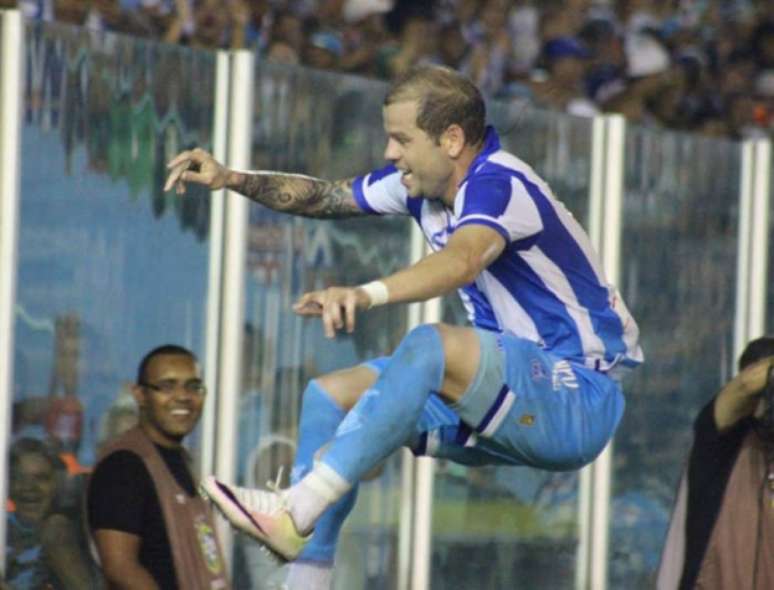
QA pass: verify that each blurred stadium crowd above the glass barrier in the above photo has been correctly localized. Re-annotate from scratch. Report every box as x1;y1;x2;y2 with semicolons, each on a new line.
0;0;774;139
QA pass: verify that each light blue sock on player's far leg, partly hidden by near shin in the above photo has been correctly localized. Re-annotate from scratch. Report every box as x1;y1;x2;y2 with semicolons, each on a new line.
291;380;357;564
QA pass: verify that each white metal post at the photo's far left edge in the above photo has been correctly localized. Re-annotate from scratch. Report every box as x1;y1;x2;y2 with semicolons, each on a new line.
0;10;24;575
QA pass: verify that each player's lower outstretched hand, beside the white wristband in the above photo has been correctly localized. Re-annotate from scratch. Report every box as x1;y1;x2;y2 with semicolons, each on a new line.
293;287;371;338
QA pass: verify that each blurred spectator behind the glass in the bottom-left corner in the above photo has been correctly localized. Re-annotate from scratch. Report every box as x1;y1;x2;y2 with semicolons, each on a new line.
5;438;98;590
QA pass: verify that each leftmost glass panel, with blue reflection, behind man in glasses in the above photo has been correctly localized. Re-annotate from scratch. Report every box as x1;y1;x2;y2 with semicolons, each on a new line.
6;24;215;588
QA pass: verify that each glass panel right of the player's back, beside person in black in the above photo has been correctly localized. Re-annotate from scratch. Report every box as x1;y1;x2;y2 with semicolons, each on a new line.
609;127;740;589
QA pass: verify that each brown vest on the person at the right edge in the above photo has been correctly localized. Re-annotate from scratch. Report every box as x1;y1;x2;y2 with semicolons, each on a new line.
695;432;774;590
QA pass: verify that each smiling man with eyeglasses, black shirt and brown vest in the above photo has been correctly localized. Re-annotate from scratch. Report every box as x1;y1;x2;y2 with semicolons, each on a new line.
87;345;230;590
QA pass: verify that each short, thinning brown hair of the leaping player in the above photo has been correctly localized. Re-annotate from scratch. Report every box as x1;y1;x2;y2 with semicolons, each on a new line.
384;65;486;145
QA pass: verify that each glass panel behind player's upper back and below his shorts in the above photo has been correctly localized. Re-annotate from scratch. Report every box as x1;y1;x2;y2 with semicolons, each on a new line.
431;104;591;590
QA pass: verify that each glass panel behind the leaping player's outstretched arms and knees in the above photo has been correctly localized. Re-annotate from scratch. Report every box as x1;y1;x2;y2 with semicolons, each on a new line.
234;64;410;590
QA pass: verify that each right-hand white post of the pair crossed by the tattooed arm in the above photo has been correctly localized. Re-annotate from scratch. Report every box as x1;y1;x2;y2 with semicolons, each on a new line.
214;51;255;559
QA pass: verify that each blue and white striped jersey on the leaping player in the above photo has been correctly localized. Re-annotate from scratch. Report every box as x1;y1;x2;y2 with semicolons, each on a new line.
353;127;643;371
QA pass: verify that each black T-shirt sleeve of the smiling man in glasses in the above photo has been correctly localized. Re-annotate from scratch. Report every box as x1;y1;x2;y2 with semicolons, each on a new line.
86;451;155;535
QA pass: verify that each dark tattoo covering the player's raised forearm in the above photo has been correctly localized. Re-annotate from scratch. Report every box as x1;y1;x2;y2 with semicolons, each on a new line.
235;173;365;219
